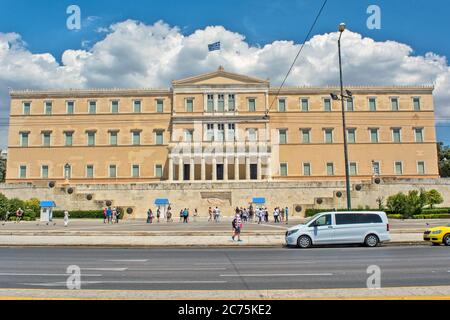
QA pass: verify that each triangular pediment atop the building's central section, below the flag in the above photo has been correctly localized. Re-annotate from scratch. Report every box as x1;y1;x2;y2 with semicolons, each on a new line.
172;67;269;87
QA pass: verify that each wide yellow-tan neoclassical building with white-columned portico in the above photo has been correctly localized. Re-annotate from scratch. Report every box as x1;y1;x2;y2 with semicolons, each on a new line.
6;68;439;185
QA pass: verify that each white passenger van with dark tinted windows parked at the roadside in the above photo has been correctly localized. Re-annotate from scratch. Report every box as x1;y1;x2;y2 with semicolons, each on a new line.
286;211;391;248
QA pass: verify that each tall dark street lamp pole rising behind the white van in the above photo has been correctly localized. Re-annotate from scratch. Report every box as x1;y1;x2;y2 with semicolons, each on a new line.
330;23;353;210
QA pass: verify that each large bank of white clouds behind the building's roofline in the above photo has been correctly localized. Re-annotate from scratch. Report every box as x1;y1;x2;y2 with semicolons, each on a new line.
0;20;450;146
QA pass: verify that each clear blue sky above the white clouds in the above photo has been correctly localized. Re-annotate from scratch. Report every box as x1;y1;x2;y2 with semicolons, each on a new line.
0;0;450;144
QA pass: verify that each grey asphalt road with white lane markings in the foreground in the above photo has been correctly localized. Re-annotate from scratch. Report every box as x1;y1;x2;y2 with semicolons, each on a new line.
0;246;450;292
